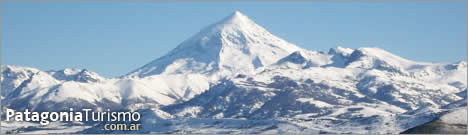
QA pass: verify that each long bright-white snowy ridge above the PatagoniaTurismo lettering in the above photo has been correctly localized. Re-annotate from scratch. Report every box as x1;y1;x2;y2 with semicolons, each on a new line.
2;66;214;111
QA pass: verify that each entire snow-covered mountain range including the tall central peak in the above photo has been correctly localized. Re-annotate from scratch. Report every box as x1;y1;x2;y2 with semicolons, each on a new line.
1;12;468;134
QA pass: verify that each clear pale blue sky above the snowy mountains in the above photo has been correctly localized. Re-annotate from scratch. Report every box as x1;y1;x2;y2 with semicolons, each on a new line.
1;1;467;77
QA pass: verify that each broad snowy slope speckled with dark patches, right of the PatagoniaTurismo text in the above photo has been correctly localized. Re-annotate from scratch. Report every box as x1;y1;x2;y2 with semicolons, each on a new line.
163;59;463;133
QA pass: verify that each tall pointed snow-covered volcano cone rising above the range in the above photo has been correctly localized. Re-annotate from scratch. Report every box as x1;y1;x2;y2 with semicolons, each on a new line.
129;11;300;77
